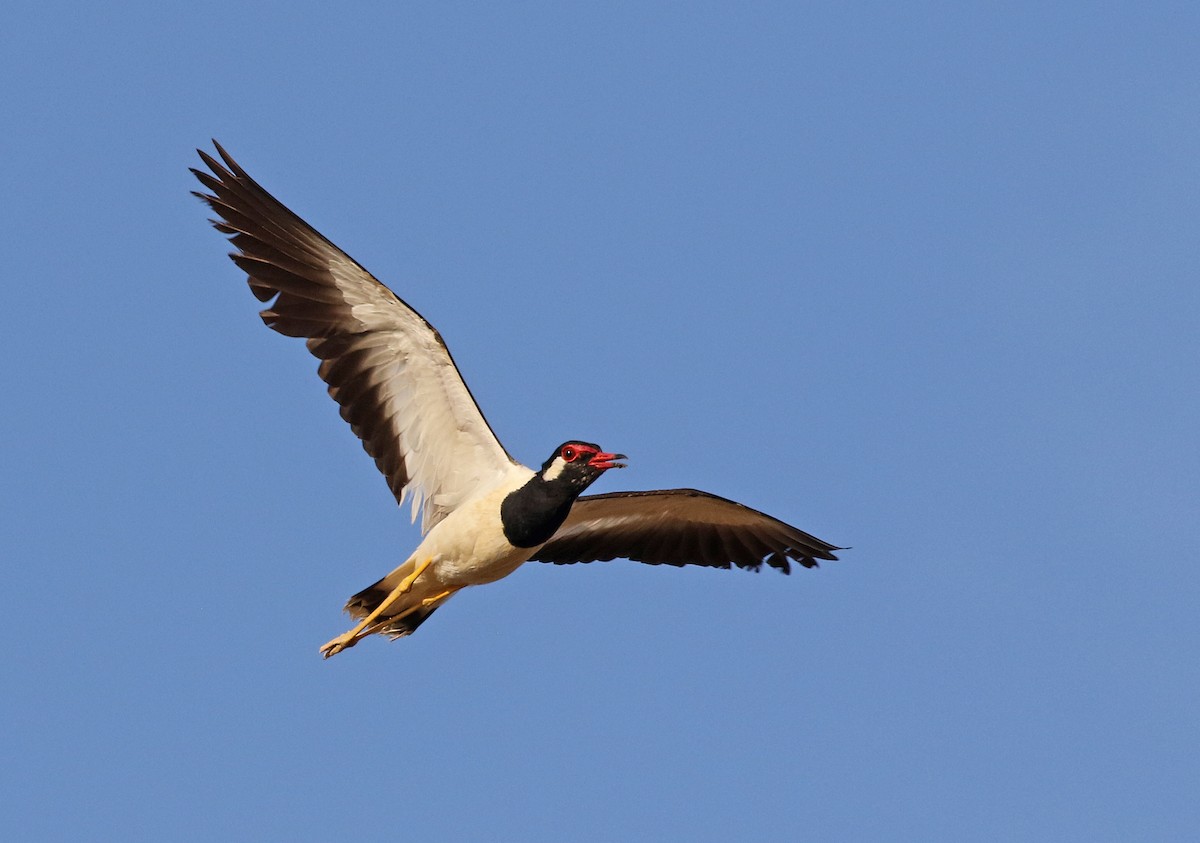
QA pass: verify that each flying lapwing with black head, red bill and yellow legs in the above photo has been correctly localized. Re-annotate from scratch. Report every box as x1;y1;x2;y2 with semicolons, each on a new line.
190;141;844;658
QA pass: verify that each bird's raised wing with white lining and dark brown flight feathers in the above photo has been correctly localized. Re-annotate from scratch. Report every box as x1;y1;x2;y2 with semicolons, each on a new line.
192;142;515;532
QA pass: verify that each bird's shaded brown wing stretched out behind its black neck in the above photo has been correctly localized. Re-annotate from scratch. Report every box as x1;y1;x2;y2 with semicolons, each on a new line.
533;489;842;574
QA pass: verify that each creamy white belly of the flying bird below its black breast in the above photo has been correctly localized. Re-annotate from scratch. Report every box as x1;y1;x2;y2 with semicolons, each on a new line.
413;467;538;586
